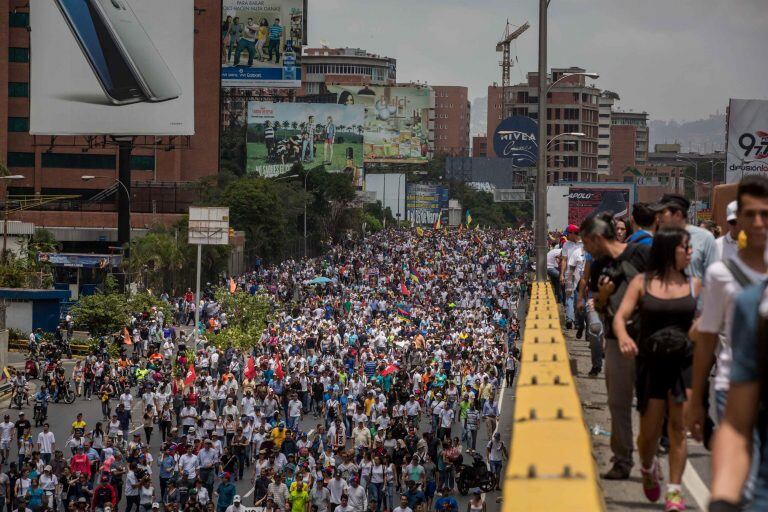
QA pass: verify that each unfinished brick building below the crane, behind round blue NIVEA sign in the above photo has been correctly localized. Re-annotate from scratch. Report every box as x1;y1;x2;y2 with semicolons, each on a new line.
487;67;602;183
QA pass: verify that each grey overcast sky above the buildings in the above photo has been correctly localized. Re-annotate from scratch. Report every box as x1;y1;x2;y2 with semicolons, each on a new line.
308;0;768;121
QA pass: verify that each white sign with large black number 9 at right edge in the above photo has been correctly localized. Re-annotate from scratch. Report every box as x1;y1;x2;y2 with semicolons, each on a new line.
725;99;768;183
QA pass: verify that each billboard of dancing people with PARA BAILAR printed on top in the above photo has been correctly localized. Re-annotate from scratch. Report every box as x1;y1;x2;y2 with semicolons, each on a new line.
221;0;306;88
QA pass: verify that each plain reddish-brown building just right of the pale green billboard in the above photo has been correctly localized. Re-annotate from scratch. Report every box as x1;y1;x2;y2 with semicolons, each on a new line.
432;85;471;156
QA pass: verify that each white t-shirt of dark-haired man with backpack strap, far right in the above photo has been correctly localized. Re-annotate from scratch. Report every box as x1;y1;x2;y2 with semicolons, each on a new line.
699;255;766;391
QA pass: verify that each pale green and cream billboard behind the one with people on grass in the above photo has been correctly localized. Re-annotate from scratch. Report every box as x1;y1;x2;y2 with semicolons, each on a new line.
328;85;432;164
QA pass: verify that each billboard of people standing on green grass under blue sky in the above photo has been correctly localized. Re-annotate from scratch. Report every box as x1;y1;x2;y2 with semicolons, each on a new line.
246;101;365;181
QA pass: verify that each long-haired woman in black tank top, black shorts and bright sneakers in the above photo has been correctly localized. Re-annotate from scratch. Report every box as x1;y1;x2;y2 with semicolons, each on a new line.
613;228;701;510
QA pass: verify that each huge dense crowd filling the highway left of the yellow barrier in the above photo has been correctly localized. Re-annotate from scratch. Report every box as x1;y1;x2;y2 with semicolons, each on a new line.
0;228;532;512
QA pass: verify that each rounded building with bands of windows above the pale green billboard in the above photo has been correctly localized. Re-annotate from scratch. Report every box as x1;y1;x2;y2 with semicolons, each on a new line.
299;48;397;96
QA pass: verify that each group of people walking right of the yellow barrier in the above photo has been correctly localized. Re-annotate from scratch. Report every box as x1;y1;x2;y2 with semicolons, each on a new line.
547;176;768;511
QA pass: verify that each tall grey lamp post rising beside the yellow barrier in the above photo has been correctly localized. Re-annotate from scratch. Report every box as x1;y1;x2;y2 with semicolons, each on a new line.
534;0;549;282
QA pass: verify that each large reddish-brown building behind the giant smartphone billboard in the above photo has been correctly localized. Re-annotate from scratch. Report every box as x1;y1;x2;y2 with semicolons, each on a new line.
0;0;221;250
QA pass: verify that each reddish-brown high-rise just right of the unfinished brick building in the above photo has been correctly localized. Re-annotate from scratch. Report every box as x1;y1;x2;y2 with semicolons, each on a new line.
610;110;648;181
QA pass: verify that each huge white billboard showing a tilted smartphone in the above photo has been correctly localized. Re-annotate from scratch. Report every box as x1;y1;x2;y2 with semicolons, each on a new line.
30;0;195;135
